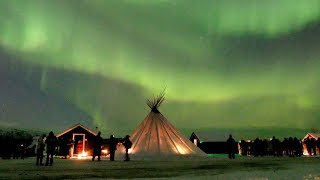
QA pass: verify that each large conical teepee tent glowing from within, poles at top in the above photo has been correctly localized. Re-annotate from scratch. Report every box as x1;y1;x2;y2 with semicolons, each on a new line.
118;91;206;158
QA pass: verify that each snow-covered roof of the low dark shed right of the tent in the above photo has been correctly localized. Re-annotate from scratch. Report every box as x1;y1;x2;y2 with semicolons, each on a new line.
193;131;229;142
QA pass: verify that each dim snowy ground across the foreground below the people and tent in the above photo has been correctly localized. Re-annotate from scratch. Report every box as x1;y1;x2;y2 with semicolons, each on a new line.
0;157;320;180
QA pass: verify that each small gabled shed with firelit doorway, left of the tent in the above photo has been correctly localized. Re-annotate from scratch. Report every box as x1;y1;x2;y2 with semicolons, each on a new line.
56;123;97;157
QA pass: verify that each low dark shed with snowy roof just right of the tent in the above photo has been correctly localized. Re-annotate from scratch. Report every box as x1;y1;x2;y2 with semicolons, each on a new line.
190;132;235;154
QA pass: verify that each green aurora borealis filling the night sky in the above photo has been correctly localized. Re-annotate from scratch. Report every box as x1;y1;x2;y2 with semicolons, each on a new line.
0;0;320;136
